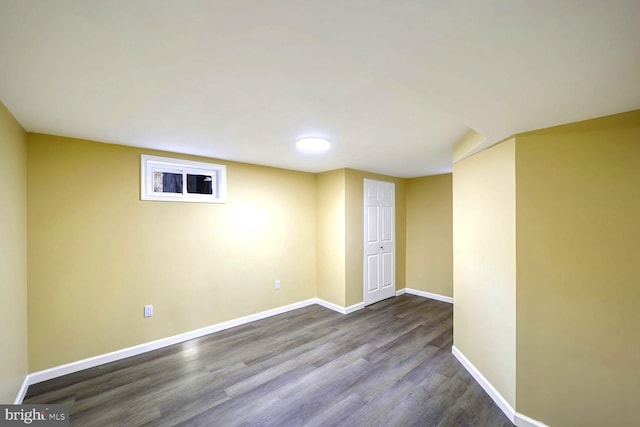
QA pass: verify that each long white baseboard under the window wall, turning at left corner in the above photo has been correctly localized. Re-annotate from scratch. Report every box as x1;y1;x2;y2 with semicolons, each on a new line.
16;298;317;404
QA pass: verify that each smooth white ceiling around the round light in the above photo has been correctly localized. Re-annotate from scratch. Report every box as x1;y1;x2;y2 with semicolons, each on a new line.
0;0;640;177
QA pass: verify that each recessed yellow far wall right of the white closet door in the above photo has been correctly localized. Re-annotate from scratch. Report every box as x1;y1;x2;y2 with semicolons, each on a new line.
406;173;453;297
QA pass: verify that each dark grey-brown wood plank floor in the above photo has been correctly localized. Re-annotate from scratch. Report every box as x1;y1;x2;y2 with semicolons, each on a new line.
25;295;512;427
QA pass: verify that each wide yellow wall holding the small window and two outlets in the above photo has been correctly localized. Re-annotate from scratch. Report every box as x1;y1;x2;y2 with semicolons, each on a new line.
27;134;316;371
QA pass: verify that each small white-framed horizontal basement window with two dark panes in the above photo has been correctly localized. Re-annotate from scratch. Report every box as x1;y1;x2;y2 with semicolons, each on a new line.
140;154;226;203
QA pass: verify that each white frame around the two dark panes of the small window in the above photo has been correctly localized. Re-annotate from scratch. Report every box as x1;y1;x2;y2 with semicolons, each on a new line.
140;154;227;203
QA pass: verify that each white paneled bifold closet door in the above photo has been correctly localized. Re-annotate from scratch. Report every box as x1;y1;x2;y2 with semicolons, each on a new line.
364;179;396;305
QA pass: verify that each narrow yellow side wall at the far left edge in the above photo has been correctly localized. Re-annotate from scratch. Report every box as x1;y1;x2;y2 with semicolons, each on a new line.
0;103;27;403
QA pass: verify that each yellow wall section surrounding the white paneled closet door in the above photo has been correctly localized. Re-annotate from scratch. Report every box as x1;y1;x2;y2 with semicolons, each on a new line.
345;169;406;306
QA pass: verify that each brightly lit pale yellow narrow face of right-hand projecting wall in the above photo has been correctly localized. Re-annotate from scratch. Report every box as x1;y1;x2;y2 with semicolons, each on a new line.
453;139;516;407
